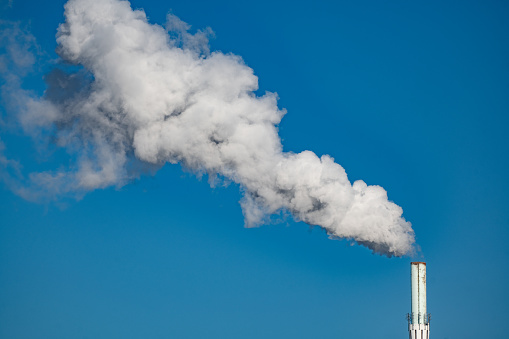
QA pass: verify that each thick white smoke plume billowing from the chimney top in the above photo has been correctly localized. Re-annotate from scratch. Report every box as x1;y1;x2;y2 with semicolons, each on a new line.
0;0;414;256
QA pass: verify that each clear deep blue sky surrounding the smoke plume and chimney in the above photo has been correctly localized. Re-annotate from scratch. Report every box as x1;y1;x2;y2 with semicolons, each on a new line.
0;0;509;339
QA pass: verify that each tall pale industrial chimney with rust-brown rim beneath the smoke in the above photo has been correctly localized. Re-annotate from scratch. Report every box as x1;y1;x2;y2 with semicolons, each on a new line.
407;262;430;339
